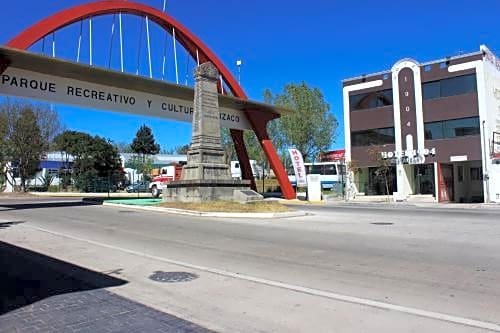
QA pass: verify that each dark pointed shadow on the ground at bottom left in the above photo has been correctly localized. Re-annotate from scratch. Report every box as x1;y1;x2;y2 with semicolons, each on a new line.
0;242;127;315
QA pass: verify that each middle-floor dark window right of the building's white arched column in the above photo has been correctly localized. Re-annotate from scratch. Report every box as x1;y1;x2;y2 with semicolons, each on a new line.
424;117;480;140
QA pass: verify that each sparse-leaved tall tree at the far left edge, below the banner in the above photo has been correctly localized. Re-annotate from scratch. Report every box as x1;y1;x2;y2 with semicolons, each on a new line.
0;99;62;191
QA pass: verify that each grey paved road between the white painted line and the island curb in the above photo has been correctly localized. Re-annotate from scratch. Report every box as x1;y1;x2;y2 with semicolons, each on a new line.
0;200;500;331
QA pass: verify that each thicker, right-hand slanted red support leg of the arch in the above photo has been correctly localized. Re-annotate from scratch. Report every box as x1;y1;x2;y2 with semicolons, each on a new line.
246;111;296;200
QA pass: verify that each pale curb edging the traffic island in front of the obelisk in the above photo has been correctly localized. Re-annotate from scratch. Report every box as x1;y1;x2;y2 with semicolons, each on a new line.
102;202;310;218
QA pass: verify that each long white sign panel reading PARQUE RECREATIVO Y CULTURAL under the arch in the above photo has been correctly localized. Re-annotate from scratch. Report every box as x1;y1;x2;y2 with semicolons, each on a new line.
0;67;251;130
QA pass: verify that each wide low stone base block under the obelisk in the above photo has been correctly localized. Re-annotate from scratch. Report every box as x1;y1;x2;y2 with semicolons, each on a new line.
162;179;250;202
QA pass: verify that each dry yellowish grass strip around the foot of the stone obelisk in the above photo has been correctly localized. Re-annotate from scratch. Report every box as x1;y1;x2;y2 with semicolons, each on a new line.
159;201;291;213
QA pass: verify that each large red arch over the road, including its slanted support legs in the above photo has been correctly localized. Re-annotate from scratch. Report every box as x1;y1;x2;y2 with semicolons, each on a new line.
7;0;295;199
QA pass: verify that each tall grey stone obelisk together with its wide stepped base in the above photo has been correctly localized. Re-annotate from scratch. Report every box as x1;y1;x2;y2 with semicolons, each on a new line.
163;62;250;202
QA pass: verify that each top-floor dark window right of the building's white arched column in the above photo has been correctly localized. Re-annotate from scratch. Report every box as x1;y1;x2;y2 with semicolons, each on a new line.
422;74;477;100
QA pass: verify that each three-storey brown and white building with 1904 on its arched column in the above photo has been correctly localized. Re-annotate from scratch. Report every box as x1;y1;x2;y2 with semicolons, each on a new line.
343;46;500;202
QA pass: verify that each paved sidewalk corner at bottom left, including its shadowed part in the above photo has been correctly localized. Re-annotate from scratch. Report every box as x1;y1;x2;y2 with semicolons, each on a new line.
0;242;210;333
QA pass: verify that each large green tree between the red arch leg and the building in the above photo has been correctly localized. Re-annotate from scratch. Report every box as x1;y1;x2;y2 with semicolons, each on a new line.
264;82;338;161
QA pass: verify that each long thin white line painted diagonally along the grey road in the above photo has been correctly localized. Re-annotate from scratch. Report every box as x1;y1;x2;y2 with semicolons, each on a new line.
20;225;500;332
